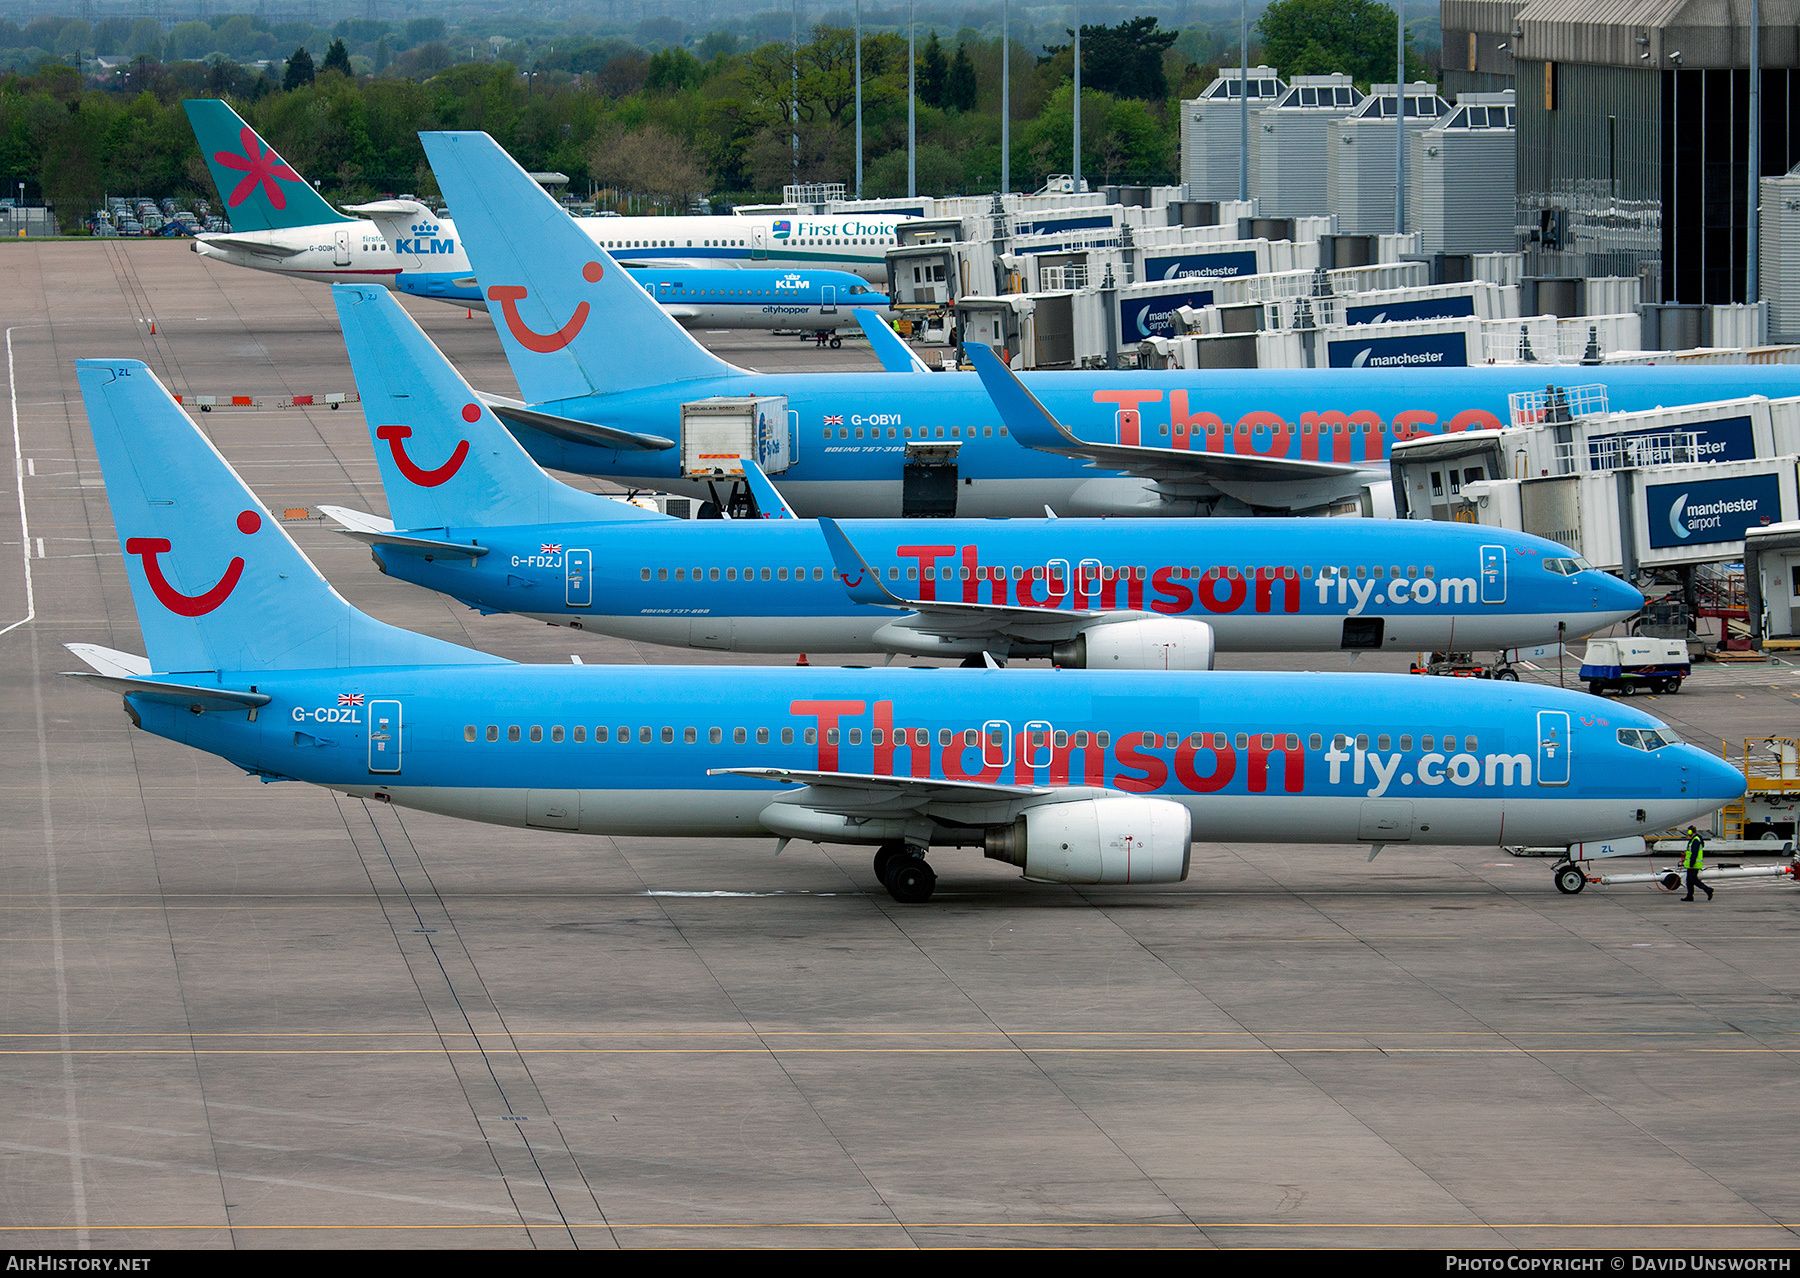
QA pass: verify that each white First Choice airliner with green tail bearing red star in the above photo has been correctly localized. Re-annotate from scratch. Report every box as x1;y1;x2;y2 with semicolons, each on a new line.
182;97;905;302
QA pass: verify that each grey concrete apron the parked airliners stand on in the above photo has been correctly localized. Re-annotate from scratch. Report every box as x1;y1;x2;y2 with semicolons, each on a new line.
0;241;1800;1247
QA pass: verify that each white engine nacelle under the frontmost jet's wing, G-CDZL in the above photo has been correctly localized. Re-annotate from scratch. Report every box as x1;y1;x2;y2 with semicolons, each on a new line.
985;797;1193;884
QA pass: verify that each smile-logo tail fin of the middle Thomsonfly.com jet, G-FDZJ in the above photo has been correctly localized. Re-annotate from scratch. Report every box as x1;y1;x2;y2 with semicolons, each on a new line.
331;284;668;529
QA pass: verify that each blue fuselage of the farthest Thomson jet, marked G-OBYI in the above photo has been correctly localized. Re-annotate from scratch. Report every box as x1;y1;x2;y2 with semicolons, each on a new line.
511;365;1800;518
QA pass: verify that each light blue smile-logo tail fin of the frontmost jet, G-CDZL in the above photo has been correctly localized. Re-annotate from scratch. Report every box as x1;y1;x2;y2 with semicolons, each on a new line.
76;360;500;673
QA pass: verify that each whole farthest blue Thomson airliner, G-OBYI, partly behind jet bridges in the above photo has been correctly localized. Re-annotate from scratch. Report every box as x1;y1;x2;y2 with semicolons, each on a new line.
421;125;1800;517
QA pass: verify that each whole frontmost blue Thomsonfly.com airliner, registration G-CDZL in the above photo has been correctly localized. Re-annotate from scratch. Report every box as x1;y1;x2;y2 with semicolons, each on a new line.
70;360;1744;902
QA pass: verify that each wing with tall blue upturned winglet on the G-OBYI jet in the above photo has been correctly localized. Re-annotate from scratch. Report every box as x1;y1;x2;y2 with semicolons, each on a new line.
963;342;1370;484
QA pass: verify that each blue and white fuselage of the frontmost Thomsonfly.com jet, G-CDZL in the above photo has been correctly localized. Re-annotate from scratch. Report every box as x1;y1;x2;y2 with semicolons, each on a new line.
130;664;1742;856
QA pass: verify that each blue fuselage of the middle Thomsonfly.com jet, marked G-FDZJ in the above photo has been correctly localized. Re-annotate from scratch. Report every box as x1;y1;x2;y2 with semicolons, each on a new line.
374;518;1643;655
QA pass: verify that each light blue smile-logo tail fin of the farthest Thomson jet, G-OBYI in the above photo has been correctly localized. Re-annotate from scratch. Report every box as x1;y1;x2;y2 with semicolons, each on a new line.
419;133;740;403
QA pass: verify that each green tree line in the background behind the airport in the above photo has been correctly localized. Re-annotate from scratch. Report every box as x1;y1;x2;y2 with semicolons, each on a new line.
0;0;1432;225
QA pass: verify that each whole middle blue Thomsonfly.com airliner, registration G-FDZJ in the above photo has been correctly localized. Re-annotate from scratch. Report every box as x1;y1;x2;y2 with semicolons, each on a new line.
320;284;1643;670
